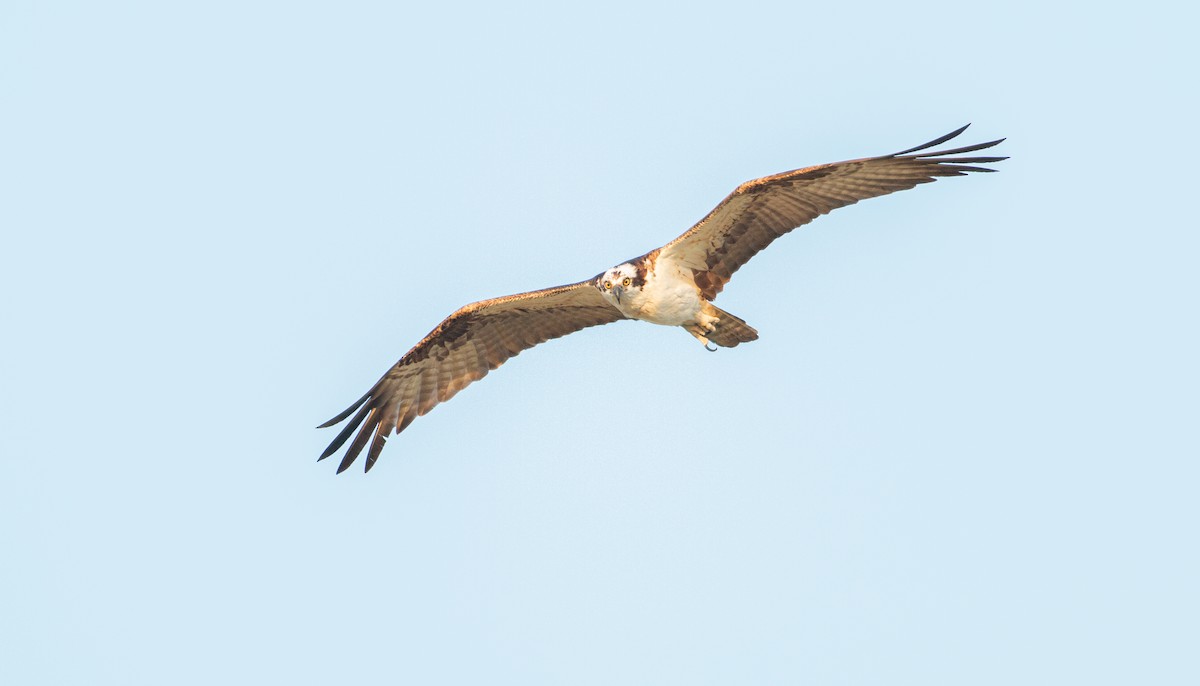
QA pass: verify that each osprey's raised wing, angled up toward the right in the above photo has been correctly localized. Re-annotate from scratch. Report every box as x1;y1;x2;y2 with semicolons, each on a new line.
659;125;1007;300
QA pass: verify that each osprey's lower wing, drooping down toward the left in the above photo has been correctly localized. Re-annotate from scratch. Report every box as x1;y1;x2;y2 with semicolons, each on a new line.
318;278;625;474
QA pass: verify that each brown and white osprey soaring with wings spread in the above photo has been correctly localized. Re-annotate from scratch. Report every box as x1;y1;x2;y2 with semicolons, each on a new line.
318;125;1007;473
